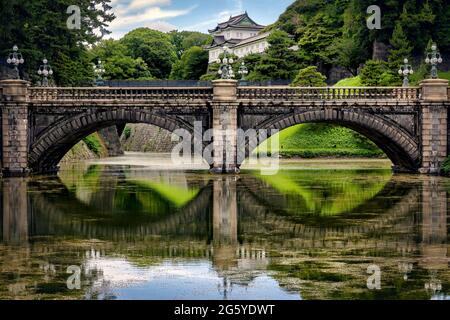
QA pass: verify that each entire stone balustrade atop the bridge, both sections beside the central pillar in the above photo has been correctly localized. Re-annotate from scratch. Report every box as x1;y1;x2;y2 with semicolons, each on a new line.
23;86;426;102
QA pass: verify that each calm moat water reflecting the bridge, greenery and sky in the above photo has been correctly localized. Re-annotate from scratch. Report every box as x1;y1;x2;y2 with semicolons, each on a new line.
0;154;450;300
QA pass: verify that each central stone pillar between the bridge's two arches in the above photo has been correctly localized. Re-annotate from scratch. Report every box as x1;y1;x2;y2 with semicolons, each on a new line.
211;80;239;173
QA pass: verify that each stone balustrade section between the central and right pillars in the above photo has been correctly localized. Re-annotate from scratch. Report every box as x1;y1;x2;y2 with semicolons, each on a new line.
238;87;420;101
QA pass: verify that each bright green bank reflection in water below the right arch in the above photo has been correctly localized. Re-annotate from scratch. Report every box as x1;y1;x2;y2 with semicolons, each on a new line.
251;170;392;216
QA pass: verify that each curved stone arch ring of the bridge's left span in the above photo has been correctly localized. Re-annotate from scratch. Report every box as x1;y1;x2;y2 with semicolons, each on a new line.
28;108;194;173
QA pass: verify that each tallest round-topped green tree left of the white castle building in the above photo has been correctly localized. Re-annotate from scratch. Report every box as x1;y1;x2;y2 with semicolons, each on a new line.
121;28;177;79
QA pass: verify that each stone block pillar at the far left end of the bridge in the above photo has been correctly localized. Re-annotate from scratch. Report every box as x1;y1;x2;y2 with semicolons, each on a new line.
0;80;29;176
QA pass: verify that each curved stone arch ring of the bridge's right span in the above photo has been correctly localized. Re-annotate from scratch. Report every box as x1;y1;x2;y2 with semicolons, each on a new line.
247;109;421;172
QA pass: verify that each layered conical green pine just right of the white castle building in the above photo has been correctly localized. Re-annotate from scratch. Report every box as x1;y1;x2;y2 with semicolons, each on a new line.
248;30;300;81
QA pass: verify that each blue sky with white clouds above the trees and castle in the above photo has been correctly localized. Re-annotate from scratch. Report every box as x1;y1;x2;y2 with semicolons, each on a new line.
109;0;294;39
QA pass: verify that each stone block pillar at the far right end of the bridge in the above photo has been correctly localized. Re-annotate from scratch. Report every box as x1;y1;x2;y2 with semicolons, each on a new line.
419;79;448;174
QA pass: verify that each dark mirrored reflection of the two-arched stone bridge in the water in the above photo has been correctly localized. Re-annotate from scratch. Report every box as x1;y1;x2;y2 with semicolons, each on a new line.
2;176;447;260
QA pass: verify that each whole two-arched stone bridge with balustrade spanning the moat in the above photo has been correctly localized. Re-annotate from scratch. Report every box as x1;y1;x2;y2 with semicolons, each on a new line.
0;79;450;176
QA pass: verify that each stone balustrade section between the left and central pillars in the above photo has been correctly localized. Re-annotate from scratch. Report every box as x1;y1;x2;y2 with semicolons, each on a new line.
29;87;213;102
